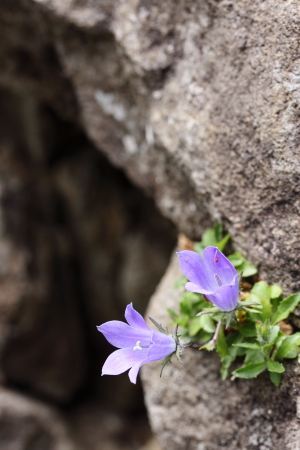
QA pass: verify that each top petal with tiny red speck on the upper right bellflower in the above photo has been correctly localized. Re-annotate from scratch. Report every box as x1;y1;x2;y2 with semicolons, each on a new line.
203;247;237;284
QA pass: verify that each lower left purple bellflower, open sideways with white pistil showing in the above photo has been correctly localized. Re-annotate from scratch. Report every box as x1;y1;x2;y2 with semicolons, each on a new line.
97;303;176;384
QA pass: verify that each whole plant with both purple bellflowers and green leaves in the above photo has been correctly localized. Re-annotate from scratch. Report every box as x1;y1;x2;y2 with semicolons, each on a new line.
97;224;300;386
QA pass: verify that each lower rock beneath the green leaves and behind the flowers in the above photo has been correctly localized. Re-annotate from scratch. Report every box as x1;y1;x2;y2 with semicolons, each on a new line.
142;255;300;450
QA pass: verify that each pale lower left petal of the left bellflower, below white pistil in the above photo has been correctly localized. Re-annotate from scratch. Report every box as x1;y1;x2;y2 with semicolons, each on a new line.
102;348;148;375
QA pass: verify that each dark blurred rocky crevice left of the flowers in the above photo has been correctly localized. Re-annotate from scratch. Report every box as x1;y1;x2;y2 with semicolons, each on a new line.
0;83;176;450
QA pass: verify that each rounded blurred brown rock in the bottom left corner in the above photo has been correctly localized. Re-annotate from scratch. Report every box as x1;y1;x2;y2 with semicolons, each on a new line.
0;388;78;450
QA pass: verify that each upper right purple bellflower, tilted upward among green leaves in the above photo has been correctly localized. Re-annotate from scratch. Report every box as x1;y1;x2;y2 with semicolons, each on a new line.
177;247;239;312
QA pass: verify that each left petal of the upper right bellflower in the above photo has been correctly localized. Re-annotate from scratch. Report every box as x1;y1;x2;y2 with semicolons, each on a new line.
177;250;216;291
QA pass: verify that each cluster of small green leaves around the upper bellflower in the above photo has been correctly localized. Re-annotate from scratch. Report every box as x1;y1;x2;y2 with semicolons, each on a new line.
169;224;300;386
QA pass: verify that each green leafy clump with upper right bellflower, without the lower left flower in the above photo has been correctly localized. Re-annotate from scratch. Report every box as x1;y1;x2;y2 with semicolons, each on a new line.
169;224;300;386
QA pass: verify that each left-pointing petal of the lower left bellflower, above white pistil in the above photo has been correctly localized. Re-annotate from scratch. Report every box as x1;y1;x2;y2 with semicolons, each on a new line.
97;320;151;349
